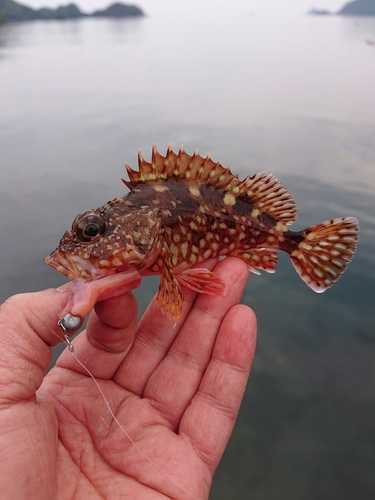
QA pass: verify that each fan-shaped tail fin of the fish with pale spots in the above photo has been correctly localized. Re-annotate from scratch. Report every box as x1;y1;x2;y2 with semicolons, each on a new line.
290;217;359;293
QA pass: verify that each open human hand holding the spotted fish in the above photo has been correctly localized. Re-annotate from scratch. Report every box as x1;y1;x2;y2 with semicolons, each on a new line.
0;258;256;500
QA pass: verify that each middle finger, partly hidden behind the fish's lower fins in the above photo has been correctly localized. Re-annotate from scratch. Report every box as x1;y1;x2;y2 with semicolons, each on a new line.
114;259;218;396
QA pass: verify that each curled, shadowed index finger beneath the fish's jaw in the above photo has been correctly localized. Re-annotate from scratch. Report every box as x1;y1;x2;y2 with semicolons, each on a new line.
56;292;138;379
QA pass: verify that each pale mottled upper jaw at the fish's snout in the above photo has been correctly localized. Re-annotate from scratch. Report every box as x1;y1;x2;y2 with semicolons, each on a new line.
44;250;108;281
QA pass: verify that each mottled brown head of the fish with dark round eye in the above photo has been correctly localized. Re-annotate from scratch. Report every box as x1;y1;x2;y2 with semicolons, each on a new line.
45;202;161;281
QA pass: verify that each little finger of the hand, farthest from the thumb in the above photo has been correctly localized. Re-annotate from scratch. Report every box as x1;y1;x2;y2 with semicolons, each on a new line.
179;305;256;472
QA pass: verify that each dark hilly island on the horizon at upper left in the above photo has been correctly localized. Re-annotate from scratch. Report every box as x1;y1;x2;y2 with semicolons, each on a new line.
0;0;144;22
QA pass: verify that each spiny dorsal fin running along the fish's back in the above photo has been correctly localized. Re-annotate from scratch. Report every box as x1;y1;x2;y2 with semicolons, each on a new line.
122;144;297;224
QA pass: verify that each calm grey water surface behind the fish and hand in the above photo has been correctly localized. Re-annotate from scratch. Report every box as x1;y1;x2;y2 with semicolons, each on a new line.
0;5;375;500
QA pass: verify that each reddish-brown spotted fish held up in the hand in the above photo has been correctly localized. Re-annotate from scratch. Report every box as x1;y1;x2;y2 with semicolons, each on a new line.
45;144;359;323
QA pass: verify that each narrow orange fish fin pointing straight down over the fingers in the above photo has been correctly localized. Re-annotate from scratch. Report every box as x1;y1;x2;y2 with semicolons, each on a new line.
157;266;184;324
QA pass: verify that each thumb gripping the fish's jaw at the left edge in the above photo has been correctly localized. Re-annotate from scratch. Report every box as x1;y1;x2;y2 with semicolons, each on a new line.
0;289;75;404
